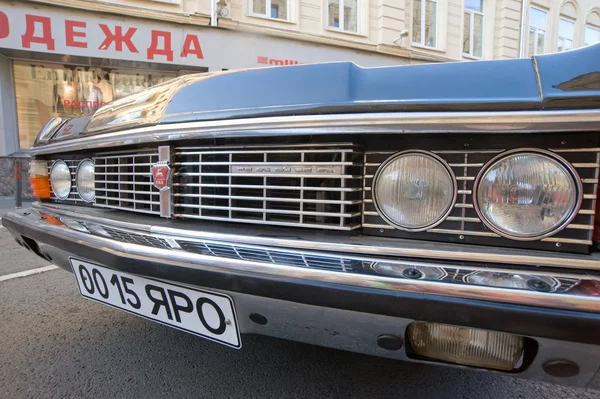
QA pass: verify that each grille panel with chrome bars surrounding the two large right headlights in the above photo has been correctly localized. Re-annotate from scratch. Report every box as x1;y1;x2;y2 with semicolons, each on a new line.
362;148;600;245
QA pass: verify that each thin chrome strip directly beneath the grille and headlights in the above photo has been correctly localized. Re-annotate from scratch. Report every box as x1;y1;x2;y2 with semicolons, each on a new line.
28;202;600;270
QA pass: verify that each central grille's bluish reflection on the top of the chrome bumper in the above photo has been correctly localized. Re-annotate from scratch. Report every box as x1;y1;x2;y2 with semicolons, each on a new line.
177;240;363;272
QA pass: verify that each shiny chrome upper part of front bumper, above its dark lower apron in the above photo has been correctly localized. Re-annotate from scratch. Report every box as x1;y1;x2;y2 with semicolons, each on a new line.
3;203;600;313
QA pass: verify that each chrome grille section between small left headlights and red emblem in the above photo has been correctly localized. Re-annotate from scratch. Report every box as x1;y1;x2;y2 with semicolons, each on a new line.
93;152;160;215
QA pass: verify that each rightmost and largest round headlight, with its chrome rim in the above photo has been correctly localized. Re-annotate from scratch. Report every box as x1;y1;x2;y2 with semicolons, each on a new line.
474;149;581;240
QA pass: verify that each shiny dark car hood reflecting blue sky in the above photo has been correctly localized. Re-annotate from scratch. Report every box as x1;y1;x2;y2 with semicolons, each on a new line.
43;44;600;141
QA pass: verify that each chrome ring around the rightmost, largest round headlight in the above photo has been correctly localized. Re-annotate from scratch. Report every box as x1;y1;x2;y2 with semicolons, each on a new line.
473;148;583;241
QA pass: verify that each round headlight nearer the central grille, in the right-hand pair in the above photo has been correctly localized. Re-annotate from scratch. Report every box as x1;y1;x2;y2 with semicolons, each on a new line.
373;150;456;231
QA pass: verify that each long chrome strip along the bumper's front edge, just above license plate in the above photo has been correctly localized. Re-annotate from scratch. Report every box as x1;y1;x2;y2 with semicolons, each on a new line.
4;209;600;312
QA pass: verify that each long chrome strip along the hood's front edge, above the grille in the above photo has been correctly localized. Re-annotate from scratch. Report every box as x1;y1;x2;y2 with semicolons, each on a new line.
30;109;600;155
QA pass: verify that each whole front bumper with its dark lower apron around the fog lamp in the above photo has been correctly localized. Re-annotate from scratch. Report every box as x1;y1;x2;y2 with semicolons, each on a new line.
2;204;600;388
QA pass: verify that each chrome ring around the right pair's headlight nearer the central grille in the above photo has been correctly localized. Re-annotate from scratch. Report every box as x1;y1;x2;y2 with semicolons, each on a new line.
371;150;458;232
